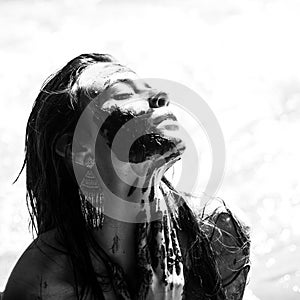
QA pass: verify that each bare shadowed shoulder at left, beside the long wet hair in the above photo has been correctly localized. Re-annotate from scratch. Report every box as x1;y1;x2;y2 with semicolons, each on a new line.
3;230;75;300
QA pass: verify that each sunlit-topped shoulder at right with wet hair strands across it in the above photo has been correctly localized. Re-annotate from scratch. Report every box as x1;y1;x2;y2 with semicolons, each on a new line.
199;199;250;299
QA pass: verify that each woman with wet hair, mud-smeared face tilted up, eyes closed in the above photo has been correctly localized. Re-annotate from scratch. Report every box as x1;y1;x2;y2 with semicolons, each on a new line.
3;54;249;300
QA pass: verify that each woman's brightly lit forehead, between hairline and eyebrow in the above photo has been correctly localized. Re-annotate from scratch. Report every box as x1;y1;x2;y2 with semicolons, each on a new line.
78;63;138;92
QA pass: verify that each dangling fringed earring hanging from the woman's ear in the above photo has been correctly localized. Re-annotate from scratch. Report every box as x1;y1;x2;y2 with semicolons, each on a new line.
80;156;104;228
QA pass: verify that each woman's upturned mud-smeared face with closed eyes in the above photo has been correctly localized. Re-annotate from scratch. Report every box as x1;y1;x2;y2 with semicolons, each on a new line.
78;63;185;163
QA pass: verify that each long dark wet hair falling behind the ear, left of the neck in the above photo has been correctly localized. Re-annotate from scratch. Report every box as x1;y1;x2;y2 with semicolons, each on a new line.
15;53;115;299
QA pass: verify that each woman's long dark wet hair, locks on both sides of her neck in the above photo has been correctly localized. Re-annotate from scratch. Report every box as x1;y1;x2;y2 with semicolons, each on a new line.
16;53;248;299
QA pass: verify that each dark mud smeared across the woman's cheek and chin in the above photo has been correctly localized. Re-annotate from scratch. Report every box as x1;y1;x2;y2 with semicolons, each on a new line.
95;107;179;163
